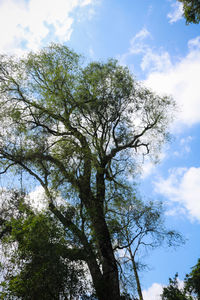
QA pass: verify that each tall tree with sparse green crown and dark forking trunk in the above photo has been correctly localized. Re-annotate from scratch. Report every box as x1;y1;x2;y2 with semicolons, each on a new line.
0;45;174;300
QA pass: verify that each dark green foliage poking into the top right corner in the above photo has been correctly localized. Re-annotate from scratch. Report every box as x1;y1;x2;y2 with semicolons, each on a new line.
178;0;200;24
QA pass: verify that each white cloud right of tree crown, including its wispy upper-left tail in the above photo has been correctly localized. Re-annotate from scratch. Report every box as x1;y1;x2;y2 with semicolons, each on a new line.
119;28;200;130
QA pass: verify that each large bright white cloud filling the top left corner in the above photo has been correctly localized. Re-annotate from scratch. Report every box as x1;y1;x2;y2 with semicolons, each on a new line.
0;0;95;54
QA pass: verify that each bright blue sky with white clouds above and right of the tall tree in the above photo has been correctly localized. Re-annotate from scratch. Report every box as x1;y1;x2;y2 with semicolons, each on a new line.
0;0;200;300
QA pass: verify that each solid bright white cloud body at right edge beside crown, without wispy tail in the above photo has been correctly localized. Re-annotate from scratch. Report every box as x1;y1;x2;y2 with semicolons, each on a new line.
145;36;200;128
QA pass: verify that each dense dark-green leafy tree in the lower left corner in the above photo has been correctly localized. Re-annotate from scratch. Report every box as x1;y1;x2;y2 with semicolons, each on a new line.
0;191;88;300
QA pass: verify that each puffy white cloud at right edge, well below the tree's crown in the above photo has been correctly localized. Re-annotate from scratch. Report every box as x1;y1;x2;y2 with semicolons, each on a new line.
155;167;200;221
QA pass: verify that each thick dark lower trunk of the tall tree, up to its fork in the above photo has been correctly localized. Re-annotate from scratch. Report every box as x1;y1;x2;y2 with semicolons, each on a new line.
80;169;120;300
